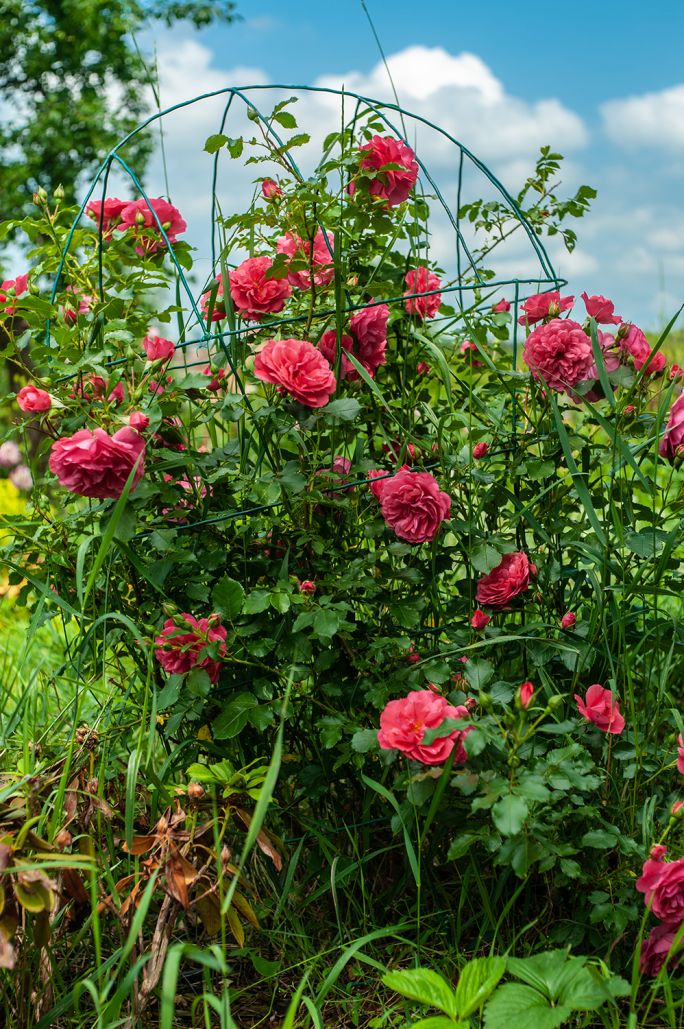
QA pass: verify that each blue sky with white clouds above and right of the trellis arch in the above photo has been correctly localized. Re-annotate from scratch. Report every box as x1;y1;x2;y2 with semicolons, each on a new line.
139;0;684;327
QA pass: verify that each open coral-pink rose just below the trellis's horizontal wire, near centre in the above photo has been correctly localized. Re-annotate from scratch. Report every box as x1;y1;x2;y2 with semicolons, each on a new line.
254;340;337;407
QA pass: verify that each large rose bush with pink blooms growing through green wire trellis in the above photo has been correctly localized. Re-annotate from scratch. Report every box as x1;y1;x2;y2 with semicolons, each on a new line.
0;96;683;1004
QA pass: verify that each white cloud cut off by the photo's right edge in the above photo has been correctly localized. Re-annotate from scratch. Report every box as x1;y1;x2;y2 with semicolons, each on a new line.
601;84;684;150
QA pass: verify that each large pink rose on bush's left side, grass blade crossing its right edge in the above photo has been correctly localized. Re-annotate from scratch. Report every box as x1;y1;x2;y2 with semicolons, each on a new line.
49;425;145;500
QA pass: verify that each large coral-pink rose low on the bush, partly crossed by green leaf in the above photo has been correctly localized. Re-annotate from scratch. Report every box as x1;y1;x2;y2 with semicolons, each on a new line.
377;689;472;765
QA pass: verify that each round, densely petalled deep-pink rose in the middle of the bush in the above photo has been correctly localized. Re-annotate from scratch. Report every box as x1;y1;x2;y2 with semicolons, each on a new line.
380;469;452;543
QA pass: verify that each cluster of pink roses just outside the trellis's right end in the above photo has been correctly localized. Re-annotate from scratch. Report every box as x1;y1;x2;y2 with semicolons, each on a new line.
518;290;684;461
